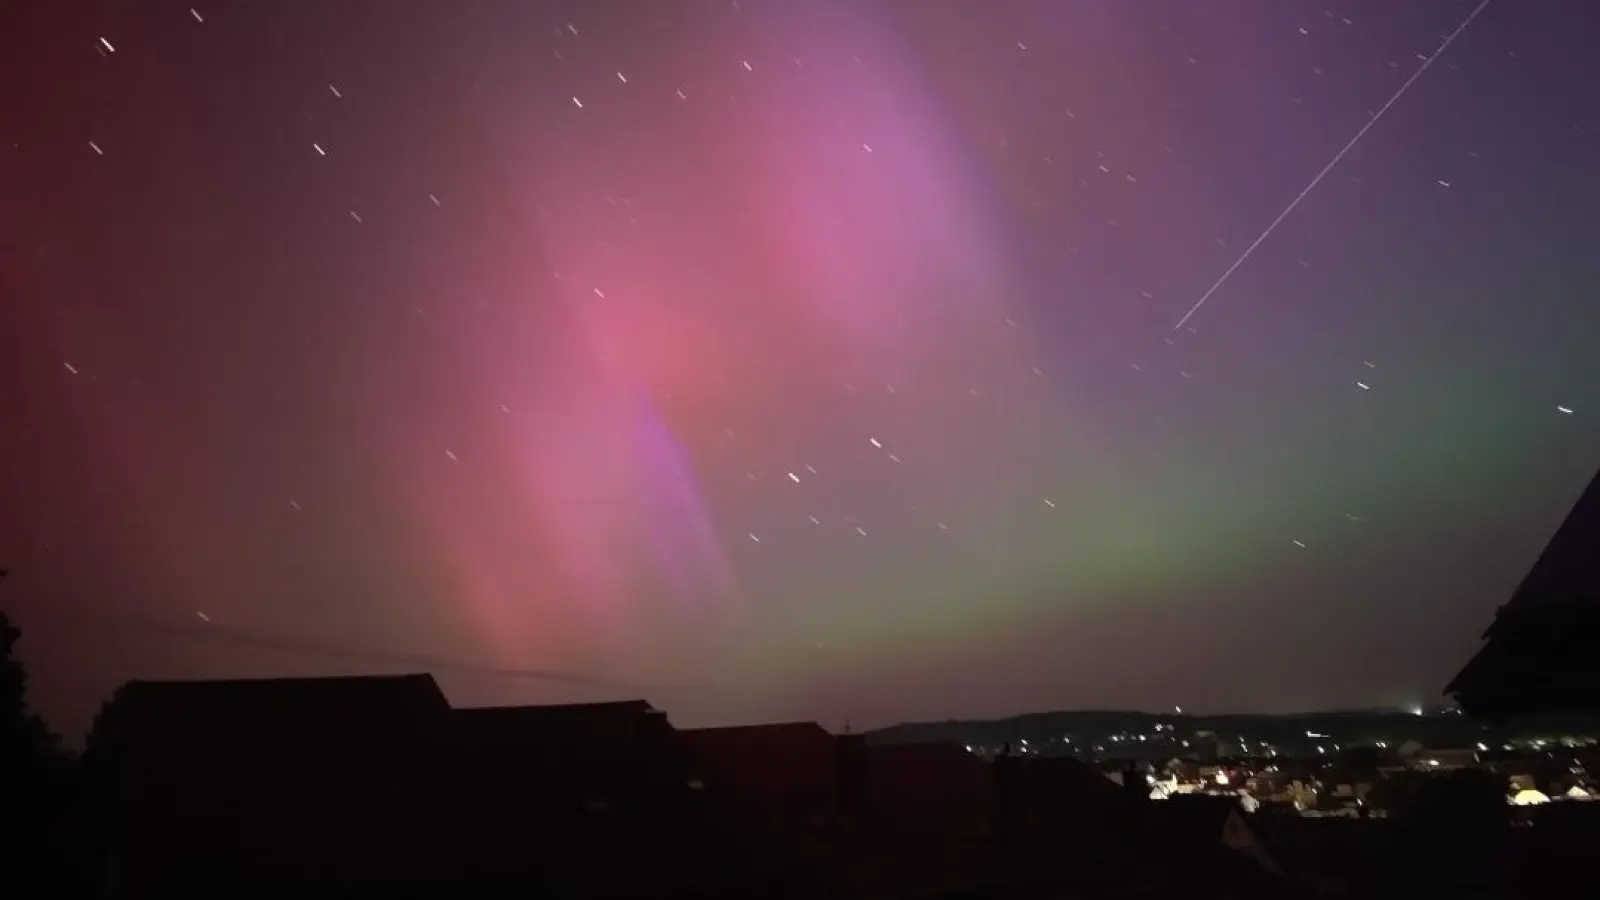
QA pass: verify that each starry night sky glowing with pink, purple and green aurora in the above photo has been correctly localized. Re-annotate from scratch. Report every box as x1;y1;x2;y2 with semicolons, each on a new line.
0;0;1600;733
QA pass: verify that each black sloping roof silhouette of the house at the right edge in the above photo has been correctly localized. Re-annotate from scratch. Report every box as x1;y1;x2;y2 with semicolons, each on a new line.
1445;461;1600;719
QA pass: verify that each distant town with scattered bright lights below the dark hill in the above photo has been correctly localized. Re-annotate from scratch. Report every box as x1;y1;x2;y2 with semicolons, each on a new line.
921;708;1600;818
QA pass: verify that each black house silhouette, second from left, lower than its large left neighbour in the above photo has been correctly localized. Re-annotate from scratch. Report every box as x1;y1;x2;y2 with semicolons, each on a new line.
451;700;819;898
